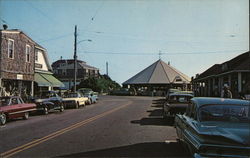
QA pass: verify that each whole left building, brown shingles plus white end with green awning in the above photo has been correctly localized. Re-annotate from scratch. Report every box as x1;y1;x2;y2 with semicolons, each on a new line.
0;25;64;98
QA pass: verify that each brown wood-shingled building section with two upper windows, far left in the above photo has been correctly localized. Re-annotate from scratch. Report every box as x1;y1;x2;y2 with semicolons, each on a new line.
0;27;36;95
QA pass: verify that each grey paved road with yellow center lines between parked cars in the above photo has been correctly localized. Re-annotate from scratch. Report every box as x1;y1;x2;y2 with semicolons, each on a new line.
0;96;187;157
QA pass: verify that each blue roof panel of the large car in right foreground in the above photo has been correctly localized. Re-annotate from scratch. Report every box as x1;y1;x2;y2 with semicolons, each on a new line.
191;97;250;106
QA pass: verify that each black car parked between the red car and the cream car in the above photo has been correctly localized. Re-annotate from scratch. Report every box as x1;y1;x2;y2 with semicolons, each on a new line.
34;91;64;115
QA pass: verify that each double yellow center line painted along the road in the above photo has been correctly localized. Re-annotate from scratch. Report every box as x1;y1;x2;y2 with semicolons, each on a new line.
0;101;132;158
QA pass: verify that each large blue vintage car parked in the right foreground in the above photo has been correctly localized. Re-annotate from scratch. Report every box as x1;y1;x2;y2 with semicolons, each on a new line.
175;98;250;157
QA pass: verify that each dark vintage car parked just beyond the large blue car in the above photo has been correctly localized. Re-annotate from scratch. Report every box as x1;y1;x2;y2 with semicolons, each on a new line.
163;93;193;118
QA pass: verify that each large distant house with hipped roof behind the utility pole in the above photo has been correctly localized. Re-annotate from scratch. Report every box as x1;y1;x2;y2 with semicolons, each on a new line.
52;59;100;89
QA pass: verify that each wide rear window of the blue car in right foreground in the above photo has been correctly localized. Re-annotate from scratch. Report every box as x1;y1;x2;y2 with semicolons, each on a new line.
199;105;250;122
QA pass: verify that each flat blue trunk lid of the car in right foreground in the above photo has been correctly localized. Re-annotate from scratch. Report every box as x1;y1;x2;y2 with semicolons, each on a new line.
196;122;250;146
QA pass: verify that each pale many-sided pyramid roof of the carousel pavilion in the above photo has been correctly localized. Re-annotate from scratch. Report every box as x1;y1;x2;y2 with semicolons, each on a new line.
123;59;191;85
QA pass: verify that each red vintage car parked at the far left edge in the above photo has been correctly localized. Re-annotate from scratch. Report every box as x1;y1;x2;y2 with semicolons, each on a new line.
0;96;36;125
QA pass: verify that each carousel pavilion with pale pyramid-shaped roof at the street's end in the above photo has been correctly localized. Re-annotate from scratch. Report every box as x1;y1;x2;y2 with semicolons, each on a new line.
123;59;191;95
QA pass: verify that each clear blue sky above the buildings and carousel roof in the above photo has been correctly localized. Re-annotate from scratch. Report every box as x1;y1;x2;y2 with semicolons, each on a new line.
0;0;249;84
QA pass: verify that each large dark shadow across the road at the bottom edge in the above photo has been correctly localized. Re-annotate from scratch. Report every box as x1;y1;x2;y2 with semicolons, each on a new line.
58;142;189;157
